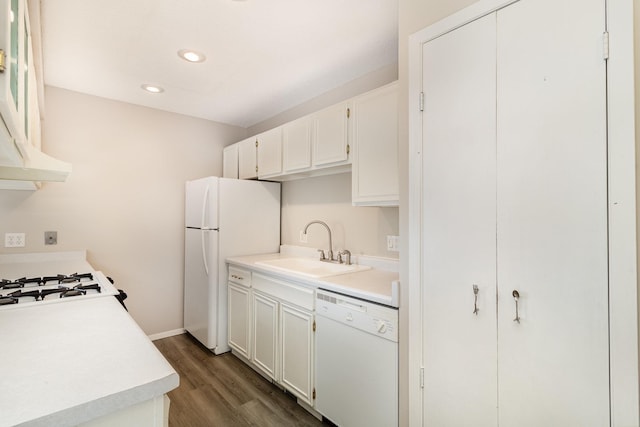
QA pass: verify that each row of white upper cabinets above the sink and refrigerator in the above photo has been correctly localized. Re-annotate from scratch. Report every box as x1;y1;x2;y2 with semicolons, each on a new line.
230;83;399;194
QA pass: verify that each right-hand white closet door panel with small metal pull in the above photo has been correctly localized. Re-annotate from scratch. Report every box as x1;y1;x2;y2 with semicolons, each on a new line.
497;0;609;427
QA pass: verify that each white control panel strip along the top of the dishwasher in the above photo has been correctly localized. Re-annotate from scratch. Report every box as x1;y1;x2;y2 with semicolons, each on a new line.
316;289;398;342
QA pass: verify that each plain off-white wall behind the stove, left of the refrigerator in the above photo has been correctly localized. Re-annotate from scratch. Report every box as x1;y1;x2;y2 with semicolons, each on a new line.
0;87;246;334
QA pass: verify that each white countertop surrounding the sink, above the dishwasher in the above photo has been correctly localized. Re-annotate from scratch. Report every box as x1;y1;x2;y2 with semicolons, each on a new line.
227;252;400;307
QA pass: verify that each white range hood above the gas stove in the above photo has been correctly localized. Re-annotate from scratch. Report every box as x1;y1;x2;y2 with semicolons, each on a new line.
0;144;71;185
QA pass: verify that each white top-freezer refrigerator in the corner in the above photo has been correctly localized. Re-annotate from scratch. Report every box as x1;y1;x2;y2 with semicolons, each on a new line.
184;177;280;354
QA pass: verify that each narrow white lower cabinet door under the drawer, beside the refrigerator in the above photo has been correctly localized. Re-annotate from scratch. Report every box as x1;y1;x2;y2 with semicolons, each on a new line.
228;282;251;360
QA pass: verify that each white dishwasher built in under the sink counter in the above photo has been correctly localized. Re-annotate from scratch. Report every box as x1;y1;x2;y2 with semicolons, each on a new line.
315;289;398;427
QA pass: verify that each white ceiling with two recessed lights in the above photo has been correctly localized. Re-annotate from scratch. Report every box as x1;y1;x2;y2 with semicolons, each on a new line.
41;0;398;127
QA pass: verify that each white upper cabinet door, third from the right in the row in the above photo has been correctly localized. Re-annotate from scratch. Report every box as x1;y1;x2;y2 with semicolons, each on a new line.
282;116;313;173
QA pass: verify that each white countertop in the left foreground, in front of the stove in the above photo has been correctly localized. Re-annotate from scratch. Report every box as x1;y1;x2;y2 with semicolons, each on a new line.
0;297;179;427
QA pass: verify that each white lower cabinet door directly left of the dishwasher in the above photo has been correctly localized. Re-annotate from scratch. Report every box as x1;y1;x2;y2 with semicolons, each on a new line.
280;303;313;405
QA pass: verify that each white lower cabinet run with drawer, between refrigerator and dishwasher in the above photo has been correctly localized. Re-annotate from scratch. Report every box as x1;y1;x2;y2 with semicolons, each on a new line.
228;267;315;407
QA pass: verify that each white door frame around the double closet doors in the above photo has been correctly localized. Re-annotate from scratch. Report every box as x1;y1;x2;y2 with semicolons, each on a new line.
405;0;640;427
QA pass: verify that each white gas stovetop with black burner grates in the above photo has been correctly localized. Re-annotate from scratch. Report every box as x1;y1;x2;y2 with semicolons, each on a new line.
0;251;120;310
